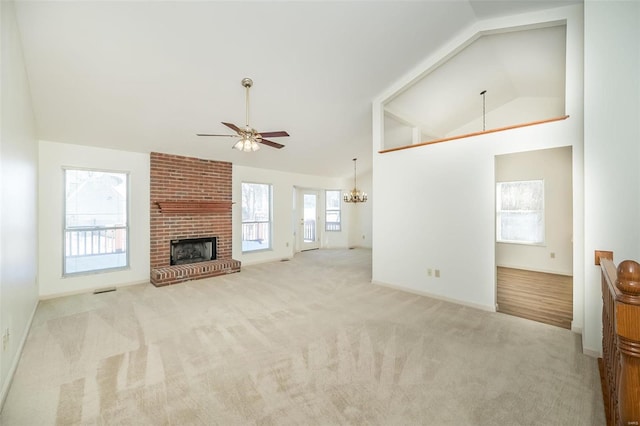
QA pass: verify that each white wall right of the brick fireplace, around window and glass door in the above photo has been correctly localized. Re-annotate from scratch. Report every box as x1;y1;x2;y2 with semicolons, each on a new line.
233;164;349;265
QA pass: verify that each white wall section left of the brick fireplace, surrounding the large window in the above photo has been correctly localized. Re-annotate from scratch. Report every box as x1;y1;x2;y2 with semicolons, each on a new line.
38;141;150;297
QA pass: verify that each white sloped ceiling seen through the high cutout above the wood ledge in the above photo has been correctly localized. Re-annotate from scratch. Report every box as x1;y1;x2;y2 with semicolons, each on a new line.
385;24;566;139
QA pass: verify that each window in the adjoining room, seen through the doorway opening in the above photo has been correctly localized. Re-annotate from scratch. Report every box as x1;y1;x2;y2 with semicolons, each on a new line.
496;180;544;244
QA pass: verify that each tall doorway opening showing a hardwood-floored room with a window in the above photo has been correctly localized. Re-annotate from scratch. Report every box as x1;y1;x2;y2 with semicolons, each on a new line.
495;146;573;329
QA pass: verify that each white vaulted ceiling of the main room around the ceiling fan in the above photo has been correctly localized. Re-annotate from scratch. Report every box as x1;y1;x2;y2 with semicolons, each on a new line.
16;0;576;177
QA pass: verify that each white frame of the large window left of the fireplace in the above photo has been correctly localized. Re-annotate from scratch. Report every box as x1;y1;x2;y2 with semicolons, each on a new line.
62;166;131;278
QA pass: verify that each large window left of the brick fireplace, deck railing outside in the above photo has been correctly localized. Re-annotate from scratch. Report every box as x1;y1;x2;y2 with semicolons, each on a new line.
63;169;129;275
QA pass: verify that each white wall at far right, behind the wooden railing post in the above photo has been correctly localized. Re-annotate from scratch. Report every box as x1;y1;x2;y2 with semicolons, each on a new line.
583;0;640;353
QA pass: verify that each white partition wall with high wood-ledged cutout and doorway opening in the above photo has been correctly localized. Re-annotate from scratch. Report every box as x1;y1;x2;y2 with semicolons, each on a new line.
373;5;584;316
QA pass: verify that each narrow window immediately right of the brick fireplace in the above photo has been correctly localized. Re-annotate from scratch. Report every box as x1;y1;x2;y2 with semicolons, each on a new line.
242;183;271;252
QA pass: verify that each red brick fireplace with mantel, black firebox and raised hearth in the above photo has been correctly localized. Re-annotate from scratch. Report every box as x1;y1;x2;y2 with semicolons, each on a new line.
150;152;240;287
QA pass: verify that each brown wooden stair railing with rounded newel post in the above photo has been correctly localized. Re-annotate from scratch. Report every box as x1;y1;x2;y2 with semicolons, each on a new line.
601;259;640;426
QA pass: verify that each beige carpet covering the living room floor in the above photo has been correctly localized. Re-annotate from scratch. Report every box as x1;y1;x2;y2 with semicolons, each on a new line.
0;249;604;426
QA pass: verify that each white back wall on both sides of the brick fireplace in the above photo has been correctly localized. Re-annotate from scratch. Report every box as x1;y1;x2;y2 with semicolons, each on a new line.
39;145;371;297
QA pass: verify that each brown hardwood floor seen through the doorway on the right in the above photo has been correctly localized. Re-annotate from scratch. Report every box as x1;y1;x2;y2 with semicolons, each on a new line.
498;266;573;329
